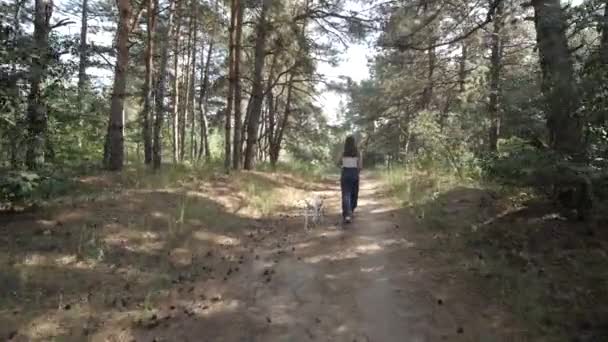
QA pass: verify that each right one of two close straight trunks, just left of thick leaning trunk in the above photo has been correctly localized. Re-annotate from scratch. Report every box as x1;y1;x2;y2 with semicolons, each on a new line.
232;0;244;170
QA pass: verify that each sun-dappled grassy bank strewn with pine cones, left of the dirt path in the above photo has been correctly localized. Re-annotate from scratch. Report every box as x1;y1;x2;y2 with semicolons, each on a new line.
0;186;282;340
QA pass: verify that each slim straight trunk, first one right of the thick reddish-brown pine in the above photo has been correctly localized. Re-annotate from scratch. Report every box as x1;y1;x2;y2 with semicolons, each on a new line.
141;0;156;165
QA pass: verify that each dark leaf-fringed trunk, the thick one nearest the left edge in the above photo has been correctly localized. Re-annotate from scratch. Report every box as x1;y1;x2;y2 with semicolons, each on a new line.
25;0;53;170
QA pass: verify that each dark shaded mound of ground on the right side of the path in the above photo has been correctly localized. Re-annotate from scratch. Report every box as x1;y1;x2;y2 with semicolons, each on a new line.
411;188;608;341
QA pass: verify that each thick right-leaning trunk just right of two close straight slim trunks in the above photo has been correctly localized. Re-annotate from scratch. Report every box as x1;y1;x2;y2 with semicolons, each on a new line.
245;0;271;170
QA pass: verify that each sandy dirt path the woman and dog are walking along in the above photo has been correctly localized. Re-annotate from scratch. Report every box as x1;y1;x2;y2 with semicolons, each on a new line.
129;176;517;342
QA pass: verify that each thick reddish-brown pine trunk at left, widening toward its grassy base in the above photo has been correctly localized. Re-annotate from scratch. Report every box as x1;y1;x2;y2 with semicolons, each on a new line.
107;0;131;171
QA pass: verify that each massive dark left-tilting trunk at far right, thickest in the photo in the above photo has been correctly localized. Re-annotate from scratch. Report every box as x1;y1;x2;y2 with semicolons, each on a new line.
532;0;584;158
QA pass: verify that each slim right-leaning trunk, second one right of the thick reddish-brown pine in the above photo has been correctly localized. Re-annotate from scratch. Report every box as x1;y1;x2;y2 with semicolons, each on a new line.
152;0;177;170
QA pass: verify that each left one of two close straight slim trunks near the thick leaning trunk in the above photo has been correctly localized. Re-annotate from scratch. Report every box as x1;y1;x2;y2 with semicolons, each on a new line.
224;0;238;172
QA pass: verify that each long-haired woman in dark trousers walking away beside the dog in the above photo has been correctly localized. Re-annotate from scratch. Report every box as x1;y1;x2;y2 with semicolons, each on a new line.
340;135;362;223
